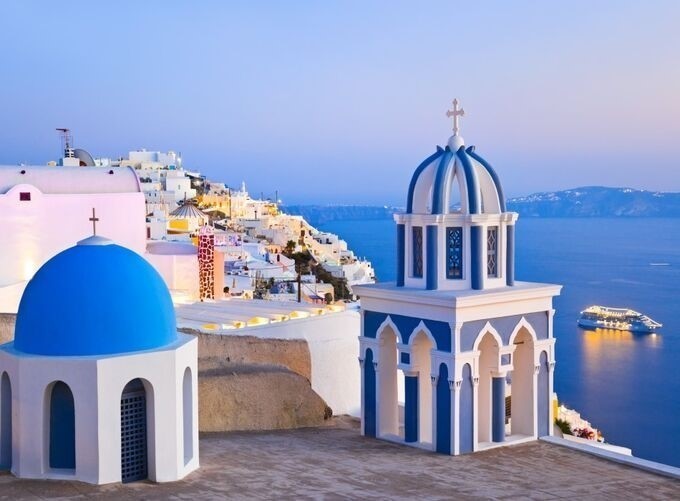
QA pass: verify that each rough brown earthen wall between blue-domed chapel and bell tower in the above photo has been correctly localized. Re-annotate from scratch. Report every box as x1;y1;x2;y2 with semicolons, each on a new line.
180;329;333;432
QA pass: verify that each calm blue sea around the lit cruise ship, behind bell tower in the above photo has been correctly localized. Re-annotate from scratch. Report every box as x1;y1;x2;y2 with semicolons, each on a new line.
323;218;680;466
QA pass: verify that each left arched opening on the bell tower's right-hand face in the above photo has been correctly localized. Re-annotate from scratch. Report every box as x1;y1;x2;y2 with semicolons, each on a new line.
477;332;499;443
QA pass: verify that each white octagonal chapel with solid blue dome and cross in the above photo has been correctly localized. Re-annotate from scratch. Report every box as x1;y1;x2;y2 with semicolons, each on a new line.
0;215;199;484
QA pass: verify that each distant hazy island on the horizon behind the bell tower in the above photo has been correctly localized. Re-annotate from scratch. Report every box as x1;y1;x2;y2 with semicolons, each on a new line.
282;186;680;226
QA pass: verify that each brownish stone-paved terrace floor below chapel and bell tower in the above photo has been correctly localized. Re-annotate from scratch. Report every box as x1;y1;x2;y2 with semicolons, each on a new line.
0;419;680;500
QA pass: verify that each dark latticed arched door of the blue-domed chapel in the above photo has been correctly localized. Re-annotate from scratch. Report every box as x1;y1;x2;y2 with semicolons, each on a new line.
120;379;149;483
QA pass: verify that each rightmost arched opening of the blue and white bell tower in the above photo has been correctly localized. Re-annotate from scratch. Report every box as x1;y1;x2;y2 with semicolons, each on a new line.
510;327;536;437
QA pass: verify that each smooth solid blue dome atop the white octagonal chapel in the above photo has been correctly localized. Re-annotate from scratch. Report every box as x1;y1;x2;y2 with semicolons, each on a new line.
14;237;177;356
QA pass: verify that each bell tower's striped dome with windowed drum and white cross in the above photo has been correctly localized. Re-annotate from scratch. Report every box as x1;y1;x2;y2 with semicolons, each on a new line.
395;99;517;290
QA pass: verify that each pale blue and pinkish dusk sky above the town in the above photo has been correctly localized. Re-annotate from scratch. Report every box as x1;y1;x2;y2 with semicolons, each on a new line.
0;0;680;205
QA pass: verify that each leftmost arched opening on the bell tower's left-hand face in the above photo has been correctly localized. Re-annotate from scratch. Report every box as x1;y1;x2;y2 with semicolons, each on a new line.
378;326;400;437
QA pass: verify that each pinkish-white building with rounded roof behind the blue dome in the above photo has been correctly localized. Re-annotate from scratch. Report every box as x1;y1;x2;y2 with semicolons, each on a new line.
0;165;146;313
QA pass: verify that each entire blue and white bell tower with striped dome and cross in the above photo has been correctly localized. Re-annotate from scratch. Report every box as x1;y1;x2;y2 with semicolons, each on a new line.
356;100;561;455
